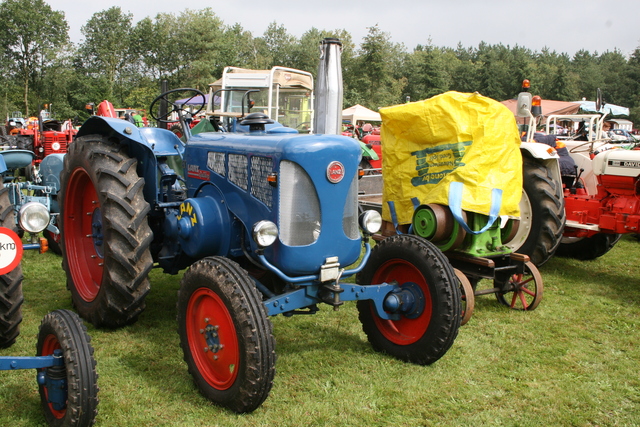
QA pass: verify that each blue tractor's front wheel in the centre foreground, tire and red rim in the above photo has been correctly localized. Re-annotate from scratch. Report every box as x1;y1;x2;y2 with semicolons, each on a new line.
178;257;276;413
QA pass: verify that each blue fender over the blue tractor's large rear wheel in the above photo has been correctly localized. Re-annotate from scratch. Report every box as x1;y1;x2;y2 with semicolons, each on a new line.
77;116;185;204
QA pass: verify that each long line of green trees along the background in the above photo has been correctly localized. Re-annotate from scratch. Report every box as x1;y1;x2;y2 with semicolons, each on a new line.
0;0;640;123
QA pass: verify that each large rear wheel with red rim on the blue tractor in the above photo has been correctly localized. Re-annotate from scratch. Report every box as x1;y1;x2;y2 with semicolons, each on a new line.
59;135;153;328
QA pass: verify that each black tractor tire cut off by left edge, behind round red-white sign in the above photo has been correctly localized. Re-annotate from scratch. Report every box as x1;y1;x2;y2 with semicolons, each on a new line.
0;182;24;348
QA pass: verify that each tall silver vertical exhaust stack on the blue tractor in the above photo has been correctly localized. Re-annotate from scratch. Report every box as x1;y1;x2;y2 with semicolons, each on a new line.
313;38;342;135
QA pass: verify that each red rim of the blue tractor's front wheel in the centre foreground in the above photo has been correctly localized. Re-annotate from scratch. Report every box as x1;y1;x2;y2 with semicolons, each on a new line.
186;288;240;390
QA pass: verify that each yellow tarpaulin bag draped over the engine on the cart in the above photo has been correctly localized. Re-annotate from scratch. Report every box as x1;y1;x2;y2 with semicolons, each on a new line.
380;92;522;224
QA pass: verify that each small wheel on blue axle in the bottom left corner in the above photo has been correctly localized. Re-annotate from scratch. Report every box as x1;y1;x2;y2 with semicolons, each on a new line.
36;310;99;426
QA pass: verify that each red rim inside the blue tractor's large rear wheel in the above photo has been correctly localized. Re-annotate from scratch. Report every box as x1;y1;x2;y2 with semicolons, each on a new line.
63;168;104;302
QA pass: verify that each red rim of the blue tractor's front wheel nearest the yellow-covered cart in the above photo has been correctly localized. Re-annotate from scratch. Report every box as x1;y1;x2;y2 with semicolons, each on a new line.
371;259;432;345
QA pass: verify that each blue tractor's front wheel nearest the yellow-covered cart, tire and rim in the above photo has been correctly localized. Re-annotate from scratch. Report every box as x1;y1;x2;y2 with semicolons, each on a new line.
358;234;462;365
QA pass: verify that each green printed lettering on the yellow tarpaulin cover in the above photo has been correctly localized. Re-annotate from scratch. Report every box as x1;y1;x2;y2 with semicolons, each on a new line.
411;141;473;187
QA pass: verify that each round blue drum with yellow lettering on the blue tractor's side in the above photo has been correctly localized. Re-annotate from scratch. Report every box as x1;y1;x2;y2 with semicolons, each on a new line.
175;184;233;259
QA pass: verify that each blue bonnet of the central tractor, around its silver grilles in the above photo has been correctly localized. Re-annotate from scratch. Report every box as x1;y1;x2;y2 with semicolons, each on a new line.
185;132;361;275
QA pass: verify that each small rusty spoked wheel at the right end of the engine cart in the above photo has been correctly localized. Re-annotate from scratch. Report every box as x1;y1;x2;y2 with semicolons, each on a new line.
496;261;543;311
